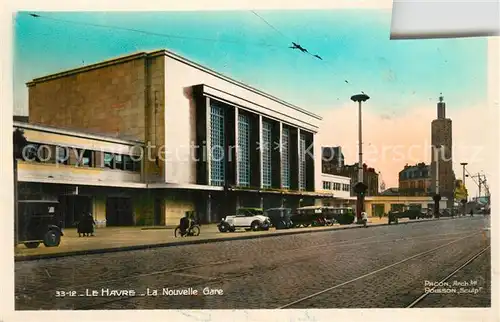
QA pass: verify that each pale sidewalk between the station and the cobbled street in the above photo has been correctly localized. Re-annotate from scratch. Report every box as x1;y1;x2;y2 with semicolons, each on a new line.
15;217;422;261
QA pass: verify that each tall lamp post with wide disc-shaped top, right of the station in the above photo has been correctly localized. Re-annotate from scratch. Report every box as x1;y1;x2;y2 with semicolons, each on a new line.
351;93;370;223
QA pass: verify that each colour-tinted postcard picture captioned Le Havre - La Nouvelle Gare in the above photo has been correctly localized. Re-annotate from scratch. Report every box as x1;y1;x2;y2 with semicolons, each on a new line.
6;3;498;320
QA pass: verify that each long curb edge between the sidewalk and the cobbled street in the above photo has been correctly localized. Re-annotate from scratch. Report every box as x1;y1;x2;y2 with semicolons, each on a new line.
14;217;460;262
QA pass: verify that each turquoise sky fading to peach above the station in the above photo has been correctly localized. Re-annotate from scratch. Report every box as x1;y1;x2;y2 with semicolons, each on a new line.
14;9;497;195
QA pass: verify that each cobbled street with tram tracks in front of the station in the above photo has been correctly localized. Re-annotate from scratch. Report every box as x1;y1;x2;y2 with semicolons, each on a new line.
15;216;490;310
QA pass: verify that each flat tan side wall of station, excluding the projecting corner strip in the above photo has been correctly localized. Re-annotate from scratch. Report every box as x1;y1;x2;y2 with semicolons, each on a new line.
29;58;146;141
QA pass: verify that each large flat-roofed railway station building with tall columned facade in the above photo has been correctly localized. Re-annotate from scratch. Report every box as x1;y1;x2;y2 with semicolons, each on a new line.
14;50;332;226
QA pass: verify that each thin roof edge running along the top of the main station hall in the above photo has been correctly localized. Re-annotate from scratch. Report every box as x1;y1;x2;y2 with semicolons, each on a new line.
26;49;323;120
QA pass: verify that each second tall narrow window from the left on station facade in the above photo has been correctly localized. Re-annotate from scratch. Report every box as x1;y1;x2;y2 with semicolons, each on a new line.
238;114;250;187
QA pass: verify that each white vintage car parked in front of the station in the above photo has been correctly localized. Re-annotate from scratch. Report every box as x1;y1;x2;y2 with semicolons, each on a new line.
217;208;271;233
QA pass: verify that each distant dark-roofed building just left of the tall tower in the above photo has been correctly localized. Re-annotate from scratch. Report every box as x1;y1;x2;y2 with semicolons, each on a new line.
399;162;432;196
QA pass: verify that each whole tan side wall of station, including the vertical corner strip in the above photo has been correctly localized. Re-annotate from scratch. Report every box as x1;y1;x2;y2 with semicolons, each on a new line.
28;55;165;182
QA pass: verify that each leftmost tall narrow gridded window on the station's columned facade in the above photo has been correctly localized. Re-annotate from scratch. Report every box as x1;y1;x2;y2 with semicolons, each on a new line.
210;105;226;186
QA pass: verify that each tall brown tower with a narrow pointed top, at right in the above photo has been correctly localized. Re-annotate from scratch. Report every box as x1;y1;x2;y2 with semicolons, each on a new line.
431;96;455;208
